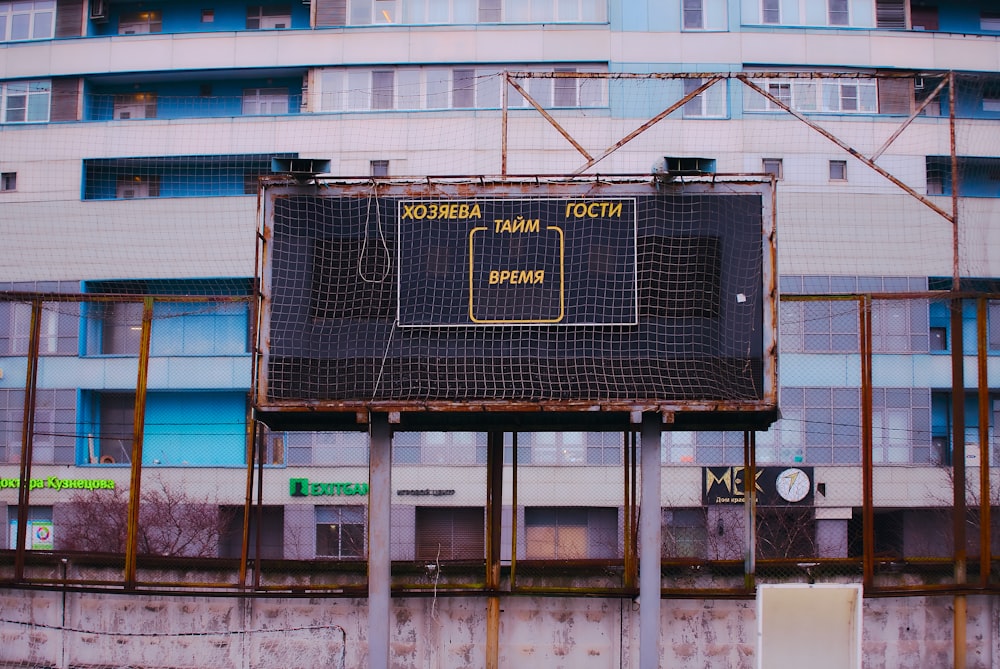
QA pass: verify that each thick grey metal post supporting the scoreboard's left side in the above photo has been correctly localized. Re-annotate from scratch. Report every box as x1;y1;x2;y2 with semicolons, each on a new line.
368;414;392;669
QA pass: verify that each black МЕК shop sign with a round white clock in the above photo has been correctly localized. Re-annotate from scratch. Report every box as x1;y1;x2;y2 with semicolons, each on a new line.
702;466;815;506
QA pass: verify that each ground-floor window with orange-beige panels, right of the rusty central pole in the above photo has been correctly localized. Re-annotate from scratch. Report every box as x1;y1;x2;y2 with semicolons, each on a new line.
524;507;619;560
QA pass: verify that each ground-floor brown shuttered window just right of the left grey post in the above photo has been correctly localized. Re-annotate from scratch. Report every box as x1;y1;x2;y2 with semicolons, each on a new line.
415;506;486;563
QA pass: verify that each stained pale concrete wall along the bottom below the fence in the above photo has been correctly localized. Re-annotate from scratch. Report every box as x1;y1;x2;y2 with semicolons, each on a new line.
0;589;1000;669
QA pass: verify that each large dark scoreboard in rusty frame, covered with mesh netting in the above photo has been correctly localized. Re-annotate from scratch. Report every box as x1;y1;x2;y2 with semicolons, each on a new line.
258;179;774;418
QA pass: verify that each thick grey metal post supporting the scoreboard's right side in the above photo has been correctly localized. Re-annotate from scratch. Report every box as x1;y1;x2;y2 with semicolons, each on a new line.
639;412;661;669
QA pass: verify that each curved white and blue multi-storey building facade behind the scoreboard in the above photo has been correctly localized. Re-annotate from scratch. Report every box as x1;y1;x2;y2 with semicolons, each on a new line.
0;0;1000;664
